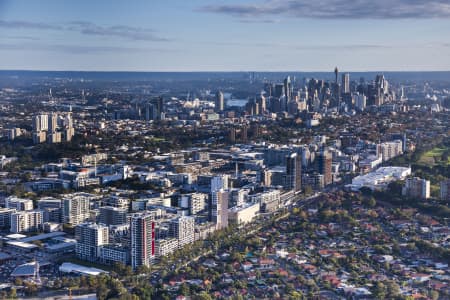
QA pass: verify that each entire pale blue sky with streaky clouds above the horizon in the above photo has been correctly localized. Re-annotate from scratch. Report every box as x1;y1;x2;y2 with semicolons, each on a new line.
0;0;450;71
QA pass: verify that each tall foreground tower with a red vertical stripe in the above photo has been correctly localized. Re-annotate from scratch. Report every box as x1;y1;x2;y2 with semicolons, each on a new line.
130;212;155;269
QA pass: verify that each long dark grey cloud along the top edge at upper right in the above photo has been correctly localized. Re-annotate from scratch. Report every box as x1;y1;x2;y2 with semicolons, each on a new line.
200;0;450;19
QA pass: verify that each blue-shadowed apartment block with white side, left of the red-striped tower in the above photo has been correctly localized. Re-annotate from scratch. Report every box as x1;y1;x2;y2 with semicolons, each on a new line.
75;222;109;261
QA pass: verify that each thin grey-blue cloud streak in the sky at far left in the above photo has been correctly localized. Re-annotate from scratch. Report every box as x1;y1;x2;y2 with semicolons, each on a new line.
0;20;169;42
